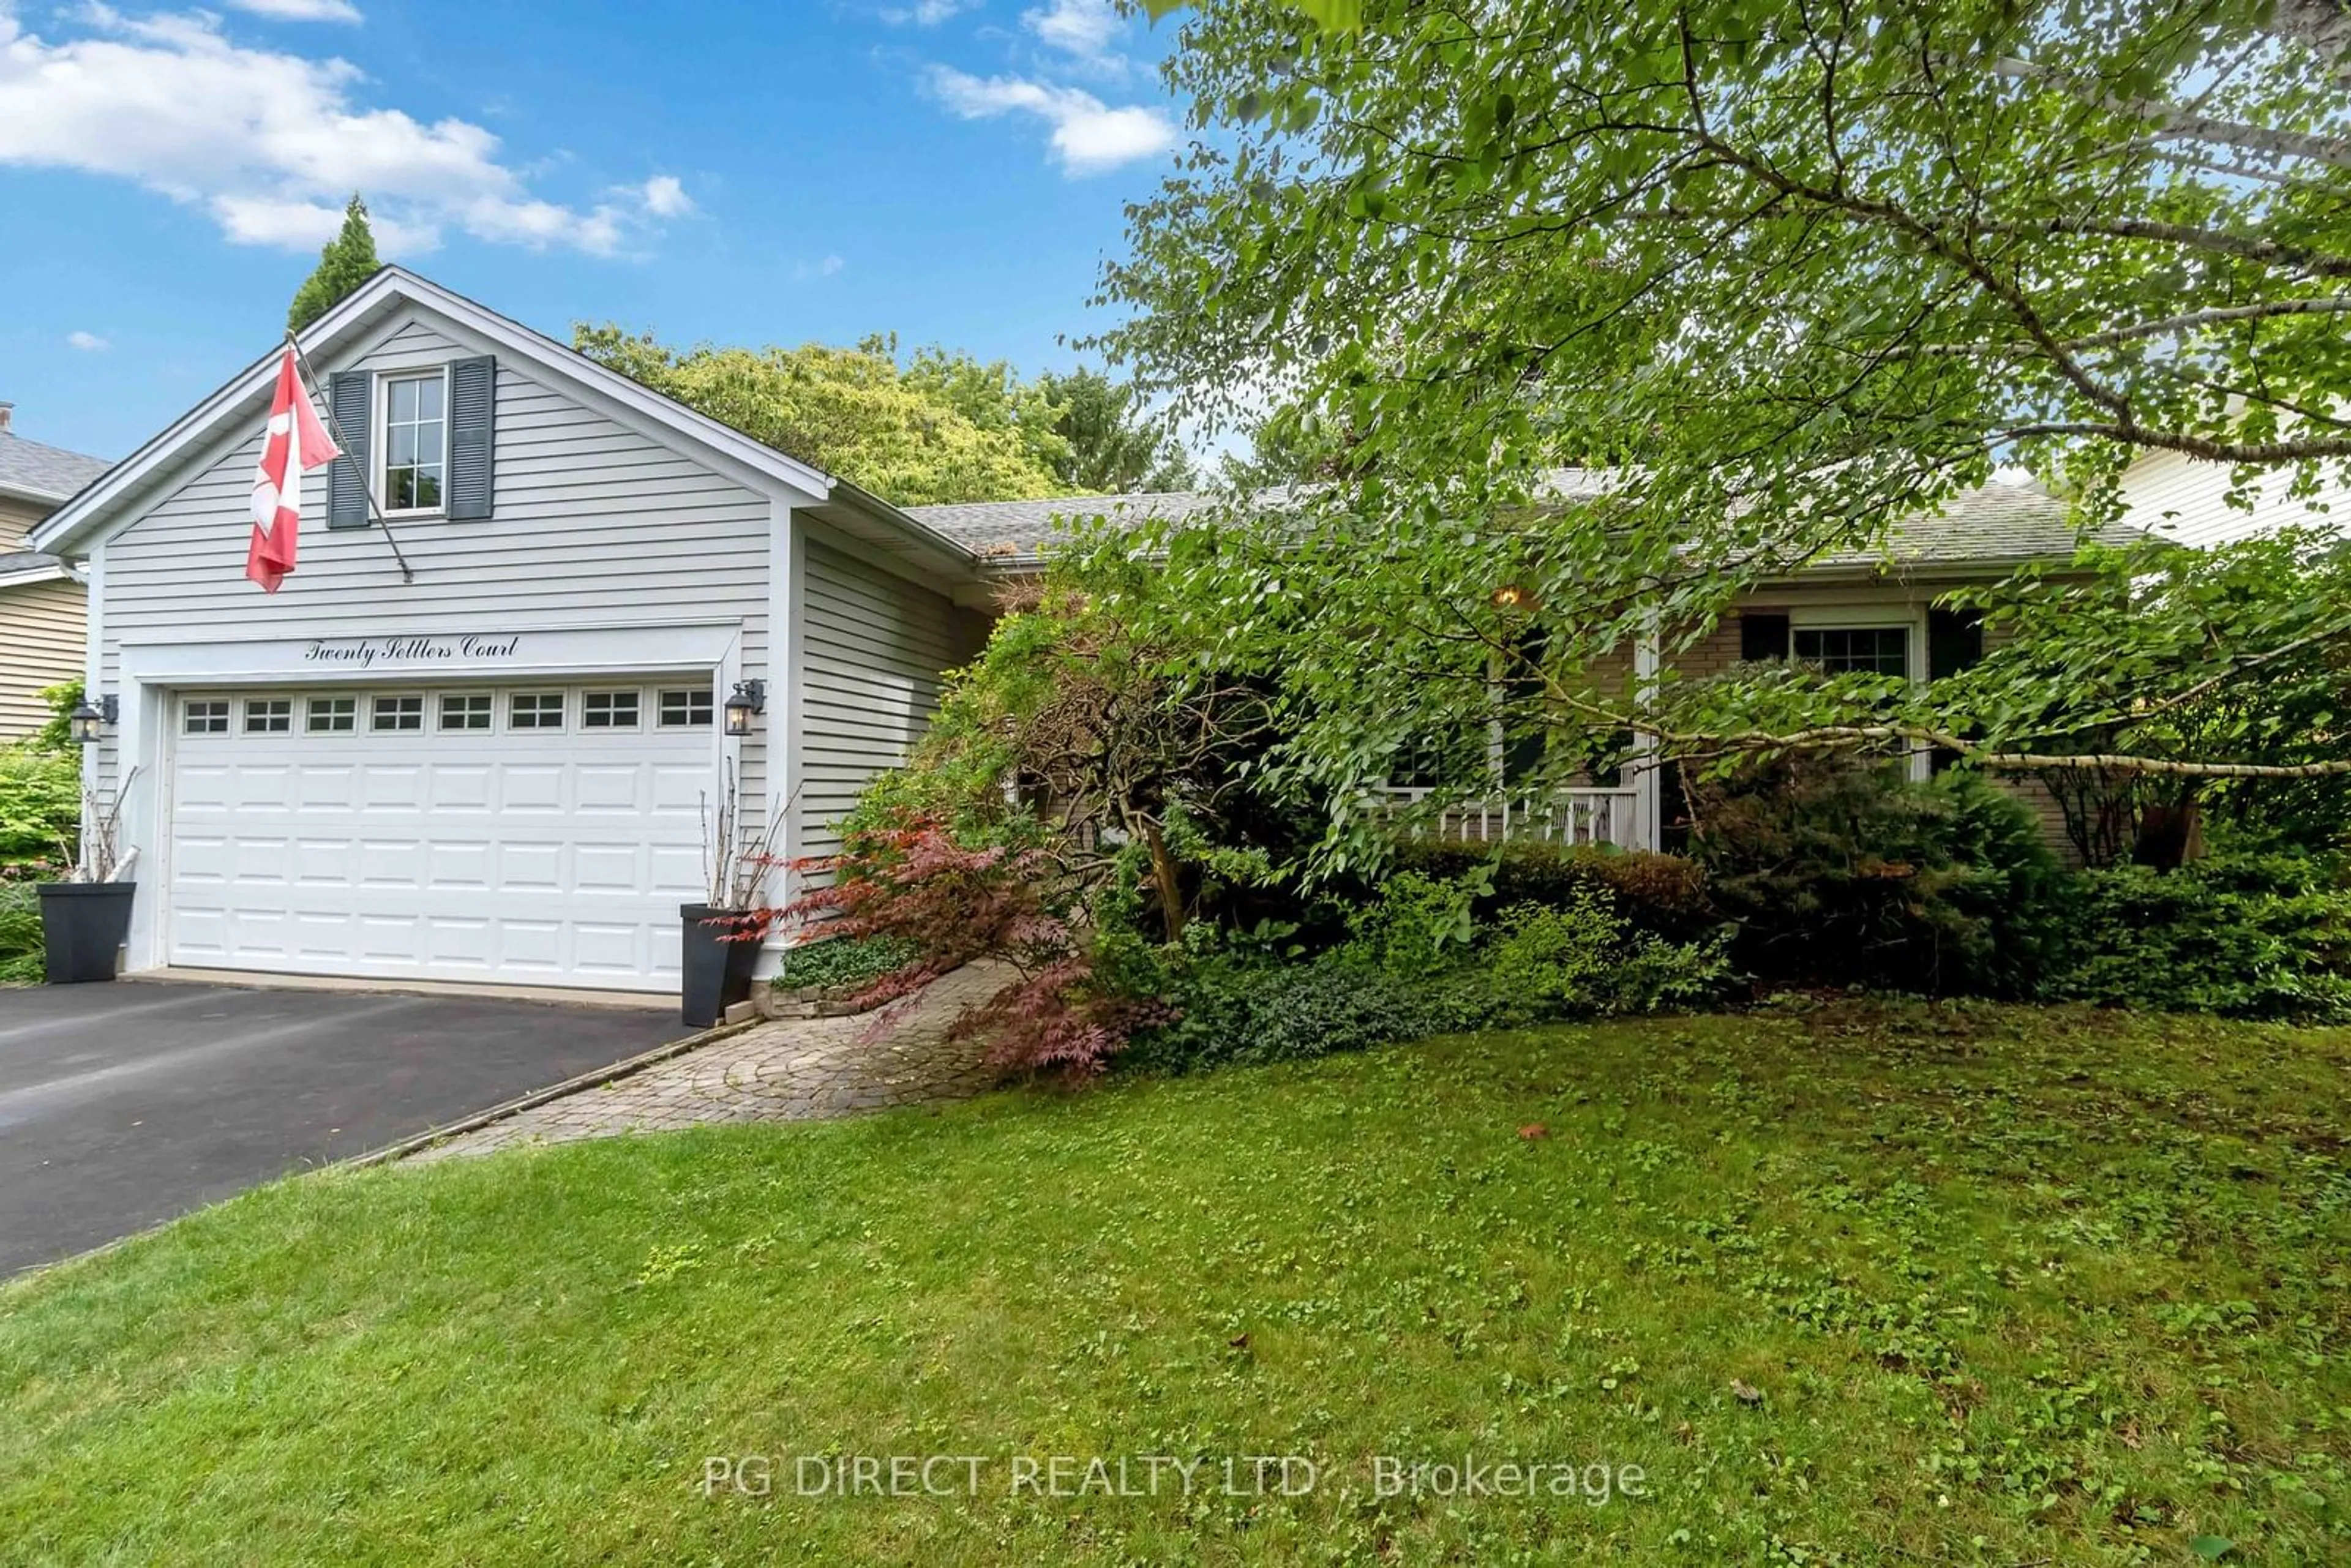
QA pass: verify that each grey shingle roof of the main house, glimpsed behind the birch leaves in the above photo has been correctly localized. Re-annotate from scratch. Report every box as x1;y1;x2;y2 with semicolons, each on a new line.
903;468;2142;566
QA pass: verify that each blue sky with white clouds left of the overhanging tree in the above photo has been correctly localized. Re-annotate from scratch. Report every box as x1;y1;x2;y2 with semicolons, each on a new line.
0;0;1183;456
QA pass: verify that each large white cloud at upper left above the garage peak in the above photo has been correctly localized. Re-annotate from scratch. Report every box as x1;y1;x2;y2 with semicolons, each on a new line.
0;0;691;257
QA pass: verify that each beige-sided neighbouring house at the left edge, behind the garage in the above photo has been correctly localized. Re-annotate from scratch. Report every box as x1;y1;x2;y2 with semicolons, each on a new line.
0;402;106;740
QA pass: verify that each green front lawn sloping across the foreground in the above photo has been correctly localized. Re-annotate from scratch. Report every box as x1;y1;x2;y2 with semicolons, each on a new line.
0;1004;2351;1566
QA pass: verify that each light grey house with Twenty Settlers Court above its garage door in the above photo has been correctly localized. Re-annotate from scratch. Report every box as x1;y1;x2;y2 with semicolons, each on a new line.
33;268;2134;992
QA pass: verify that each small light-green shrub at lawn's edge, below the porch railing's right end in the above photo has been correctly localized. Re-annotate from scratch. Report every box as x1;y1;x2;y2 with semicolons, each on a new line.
1483;891;1733;1018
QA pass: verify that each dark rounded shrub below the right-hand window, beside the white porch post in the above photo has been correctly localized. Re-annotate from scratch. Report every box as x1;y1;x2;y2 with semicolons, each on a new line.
1690;757;2066;997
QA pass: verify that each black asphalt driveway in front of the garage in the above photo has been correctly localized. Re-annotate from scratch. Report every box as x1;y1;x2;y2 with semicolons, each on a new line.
0;983;689;1277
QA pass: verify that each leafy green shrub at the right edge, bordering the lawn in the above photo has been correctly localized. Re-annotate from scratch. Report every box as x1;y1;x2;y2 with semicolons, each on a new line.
2050;856;2351;1022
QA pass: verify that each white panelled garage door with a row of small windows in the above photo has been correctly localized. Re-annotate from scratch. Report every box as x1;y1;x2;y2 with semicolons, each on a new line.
165;677;714;989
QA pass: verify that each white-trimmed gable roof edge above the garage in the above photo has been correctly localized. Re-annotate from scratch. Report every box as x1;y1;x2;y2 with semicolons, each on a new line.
28;266;973;576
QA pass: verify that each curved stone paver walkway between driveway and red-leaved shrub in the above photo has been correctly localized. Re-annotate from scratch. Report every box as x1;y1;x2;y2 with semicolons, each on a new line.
411;964;1007;1159
